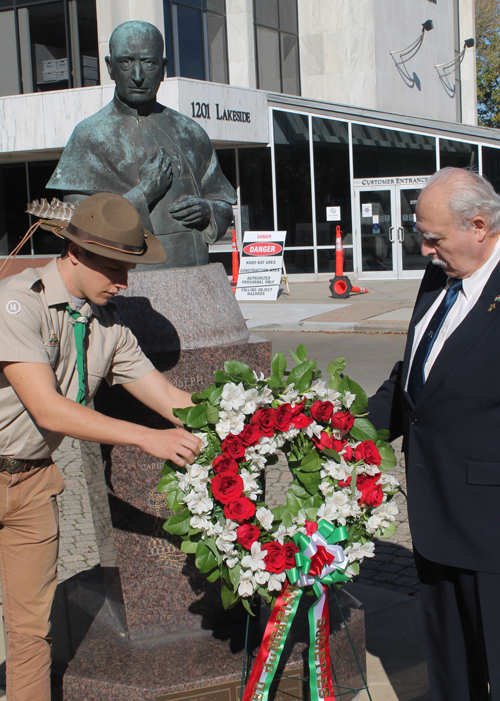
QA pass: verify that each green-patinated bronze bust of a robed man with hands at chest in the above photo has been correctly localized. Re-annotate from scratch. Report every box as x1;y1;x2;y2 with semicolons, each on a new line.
47;21;236;270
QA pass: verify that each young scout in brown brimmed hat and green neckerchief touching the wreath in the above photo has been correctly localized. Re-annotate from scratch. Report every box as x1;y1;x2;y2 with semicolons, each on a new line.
0;193;201;701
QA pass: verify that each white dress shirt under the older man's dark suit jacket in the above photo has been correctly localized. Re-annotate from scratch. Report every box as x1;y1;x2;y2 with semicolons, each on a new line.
405;238;500;389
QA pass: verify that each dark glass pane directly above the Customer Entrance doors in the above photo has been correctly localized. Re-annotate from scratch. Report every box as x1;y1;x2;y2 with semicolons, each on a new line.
352;124;436;178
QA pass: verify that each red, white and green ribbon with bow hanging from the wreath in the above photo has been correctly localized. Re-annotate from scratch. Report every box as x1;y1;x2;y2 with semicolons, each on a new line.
242;520;349;701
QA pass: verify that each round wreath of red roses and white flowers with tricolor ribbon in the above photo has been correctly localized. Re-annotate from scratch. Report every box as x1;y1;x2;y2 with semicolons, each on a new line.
158;345;400;701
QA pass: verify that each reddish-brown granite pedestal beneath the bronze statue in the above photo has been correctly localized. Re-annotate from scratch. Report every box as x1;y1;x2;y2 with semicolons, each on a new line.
54;264;364;701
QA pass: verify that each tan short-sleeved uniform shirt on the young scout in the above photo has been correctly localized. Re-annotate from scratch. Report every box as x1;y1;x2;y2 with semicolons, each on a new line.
0;259;154;460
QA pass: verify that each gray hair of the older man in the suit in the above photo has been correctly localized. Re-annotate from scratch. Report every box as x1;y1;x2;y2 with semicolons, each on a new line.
420;167;500;234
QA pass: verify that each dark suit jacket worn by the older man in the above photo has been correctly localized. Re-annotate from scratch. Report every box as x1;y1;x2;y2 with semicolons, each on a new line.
368;264;500;574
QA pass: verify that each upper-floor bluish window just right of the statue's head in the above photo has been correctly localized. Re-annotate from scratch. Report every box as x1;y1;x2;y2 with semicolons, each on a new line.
163;0;229;83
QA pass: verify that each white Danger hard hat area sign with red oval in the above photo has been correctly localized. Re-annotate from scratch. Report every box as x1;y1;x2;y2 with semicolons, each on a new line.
236;231;286;300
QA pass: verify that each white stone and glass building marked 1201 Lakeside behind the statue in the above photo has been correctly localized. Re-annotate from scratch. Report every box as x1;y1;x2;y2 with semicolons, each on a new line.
0;0;500;279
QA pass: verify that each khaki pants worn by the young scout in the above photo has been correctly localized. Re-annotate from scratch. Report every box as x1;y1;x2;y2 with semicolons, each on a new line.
0;463;64;701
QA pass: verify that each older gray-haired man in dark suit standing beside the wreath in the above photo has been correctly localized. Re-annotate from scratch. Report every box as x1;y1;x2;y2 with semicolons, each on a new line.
369;168;500;701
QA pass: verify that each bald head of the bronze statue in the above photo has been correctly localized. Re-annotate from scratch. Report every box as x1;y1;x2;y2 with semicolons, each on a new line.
106;21;167;108
